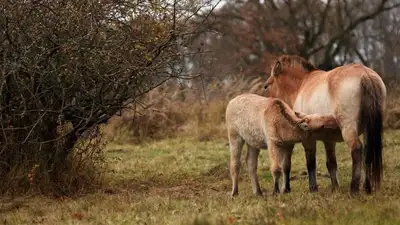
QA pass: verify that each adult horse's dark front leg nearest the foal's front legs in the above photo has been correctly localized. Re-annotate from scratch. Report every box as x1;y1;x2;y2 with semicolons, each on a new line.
302;140;318;192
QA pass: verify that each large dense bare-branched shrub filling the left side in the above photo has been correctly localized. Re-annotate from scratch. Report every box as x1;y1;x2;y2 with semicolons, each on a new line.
0;0;217;194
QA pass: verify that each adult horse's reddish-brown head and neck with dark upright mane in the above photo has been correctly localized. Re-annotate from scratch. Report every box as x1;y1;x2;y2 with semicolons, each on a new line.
264;55;317;104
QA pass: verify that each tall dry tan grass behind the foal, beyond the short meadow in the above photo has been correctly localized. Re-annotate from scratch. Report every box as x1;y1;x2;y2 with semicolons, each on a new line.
105;77;400;143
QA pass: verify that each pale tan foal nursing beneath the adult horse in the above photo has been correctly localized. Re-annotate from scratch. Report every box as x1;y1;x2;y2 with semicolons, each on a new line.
225;94;337;196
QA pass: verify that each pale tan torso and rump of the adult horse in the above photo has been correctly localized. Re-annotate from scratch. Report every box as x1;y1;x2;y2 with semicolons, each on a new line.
293;63;386;141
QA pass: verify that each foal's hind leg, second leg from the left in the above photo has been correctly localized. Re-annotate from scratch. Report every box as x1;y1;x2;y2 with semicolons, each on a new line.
246;145;262;196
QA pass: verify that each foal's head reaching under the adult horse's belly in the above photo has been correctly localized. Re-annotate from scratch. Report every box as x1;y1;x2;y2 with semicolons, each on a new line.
295;112;339;131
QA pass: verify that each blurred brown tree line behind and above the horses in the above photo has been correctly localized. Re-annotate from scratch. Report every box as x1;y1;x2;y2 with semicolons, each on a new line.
189;0;400;79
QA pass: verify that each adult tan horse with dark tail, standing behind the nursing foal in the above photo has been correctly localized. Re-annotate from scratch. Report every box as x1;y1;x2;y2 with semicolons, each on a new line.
264;55;386;194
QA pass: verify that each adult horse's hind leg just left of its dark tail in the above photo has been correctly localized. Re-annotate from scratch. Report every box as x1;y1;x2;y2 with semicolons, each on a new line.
342;126;362;194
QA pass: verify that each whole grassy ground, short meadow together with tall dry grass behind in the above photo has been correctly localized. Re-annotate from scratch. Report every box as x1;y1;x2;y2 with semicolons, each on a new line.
0;77;400;225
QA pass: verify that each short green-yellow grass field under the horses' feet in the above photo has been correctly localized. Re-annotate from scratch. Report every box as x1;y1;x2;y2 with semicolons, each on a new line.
0;131;400;225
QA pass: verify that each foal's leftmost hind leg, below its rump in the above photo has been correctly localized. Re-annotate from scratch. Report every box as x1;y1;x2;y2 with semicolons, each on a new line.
229;132;244;196
